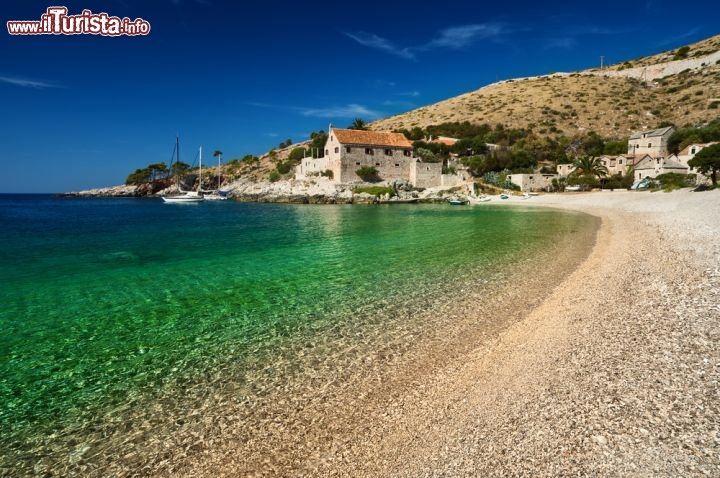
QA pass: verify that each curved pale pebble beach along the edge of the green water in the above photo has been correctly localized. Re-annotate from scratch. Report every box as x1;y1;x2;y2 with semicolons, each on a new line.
177;190;720;477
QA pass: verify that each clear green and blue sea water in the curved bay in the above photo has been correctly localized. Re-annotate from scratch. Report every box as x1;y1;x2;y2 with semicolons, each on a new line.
0;195;596;475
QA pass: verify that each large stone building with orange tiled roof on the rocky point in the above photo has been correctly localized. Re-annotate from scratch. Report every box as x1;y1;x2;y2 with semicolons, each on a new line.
295;125;442;188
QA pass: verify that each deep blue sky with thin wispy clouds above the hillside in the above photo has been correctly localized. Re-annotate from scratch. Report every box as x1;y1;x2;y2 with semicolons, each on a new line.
0;0;720;192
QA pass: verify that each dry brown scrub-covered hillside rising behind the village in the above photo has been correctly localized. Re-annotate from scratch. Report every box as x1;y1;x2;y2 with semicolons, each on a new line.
370;35;720;138
